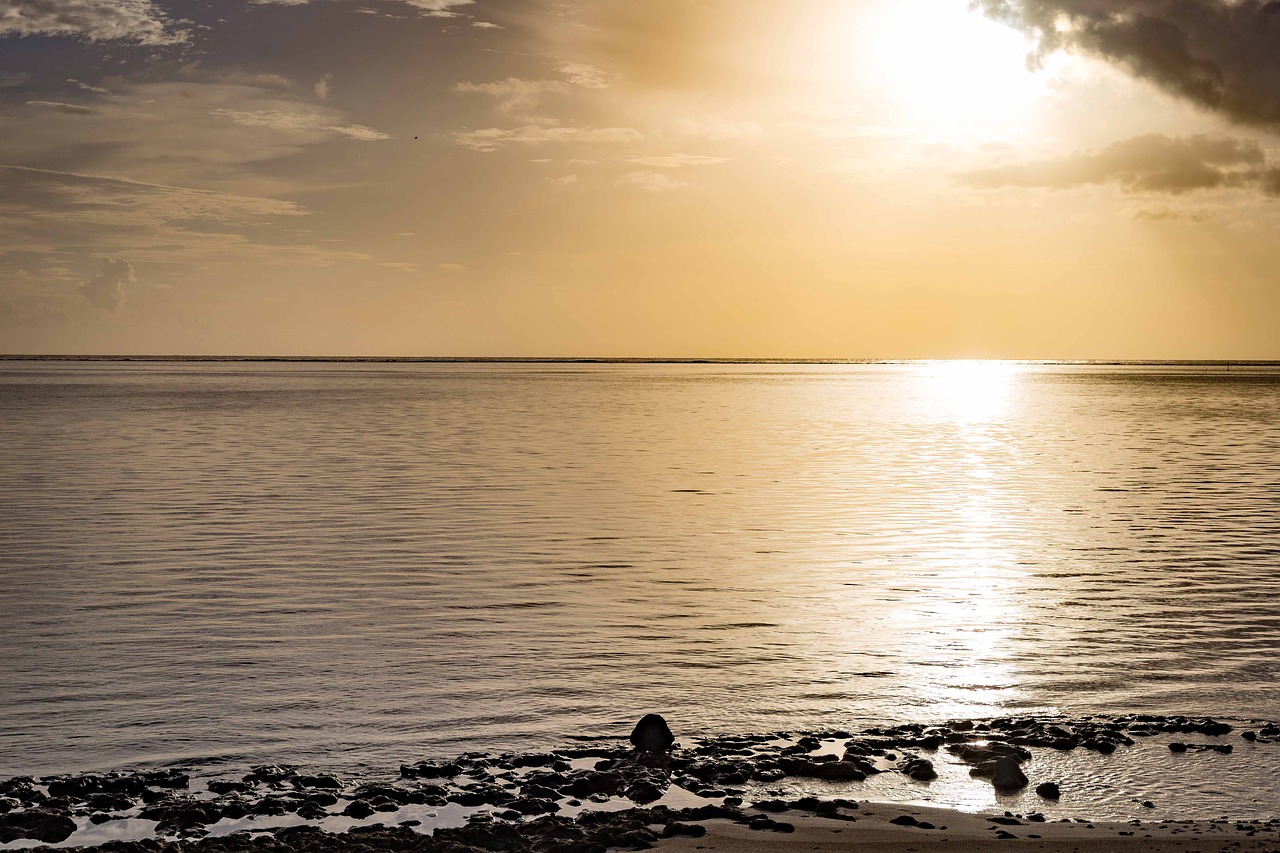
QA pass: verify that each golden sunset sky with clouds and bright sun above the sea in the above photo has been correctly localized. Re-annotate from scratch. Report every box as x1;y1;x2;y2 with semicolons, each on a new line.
0;0;1280;359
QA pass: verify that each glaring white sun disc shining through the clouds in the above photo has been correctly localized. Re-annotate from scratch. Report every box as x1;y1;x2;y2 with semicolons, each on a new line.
861;0;1047;131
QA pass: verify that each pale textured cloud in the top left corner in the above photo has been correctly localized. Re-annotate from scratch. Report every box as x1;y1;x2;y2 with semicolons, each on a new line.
0;0;187;45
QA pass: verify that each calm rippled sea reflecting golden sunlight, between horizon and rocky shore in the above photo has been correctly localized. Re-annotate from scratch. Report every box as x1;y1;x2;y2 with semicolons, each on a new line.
0;362;1280;809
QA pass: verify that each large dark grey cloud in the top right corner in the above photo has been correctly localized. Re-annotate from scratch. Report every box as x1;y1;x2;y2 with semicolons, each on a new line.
974;0;1280;126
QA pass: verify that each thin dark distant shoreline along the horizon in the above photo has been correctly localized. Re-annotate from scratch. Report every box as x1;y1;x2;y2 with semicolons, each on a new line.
0;353;1280;368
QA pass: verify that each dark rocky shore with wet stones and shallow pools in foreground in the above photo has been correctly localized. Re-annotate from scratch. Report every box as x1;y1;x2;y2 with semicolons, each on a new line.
0;715;1280;853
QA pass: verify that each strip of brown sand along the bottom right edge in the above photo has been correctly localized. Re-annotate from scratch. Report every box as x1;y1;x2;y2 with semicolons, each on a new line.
657;803;1280;853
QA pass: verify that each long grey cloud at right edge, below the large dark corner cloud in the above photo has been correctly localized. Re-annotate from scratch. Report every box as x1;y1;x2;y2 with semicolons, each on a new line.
961;133;1280;195
